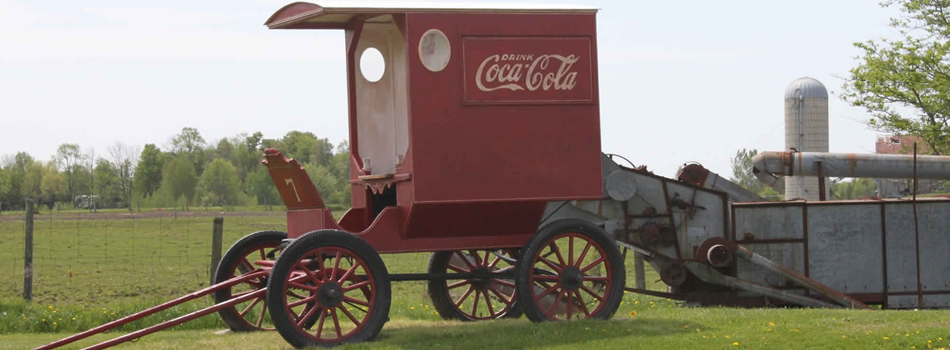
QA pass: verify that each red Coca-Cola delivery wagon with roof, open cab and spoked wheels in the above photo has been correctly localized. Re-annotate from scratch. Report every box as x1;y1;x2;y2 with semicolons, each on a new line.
245;2;624;347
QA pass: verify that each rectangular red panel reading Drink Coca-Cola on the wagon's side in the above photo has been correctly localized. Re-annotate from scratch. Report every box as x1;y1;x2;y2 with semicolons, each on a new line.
462;36;594;104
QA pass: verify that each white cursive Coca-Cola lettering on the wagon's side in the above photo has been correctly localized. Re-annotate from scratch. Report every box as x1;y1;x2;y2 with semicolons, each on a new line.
475;54;580;92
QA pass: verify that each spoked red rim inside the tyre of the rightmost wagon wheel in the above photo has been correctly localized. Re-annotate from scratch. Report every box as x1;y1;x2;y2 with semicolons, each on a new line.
529;233;614;320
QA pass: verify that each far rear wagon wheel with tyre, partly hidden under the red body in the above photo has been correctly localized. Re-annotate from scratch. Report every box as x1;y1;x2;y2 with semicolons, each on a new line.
429;250;522;321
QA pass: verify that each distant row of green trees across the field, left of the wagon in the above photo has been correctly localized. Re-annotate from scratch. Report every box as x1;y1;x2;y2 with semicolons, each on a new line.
0;128;350;211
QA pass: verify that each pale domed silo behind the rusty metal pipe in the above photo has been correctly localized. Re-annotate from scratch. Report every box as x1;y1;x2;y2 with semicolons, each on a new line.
785;77;830;201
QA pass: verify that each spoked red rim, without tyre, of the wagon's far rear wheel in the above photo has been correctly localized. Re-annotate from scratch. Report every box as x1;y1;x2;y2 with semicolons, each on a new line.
442;250;517;320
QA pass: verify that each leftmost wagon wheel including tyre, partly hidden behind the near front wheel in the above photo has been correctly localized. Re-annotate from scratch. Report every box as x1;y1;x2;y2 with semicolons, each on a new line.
213;231;287;332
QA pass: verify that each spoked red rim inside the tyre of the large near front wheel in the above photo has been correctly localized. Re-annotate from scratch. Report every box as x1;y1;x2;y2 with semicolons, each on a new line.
283;246;376;343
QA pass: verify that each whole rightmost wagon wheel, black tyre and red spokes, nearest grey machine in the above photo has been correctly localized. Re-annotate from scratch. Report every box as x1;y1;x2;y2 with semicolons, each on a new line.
516;219;626;322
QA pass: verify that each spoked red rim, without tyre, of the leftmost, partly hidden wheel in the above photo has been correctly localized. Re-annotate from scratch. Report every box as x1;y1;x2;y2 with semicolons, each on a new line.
226;244;277;331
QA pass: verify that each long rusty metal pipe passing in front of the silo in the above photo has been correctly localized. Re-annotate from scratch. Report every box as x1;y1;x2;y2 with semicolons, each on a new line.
752;152;950;186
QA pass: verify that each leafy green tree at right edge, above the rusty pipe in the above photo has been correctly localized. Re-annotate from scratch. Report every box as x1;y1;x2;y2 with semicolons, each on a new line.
841;0;950;154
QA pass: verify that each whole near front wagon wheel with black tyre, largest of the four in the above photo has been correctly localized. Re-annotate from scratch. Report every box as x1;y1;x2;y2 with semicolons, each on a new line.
267;230;391;348
